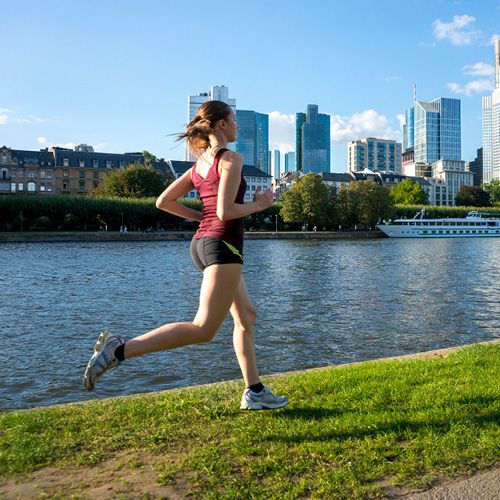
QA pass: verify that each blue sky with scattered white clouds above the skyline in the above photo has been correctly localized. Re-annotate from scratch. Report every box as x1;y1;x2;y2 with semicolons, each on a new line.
0;0;500;172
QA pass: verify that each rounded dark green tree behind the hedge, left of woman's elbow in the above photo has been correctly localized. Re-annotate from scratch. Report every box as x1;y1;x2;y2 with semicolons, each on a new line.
92;162;169;198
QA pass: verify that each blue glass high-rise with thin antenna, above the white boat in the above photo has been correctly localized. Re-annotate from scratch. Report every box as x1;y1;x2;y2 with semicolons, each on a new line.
403;97;462;164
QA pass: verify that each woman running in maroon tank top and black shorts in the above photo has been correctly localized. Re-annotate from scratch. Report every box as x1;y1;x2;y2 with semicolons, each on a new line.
84;101;288;410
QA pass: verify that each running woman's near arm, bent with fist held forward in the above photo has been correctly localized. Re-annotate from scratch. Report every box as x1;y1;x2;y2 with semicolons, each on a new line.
217;151;274;220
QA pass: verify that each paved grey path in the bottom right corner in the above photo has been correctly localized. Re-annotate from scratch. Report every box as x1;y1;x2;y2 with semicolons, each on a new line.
405;467;500;500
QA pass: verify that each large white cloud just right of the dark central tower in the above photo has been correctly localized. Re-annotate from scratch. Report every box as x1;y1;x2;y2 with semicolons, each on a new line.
331;109;404;143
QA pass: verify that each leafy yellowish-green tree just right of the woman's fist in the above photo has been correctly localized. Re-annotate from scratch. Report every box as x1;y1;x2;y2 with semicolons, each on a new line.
280;173;333;227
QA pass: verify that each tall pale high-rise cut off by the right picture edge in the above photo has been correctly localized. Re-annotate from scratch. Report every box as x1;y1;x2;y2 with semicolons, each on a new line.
483;38;500;184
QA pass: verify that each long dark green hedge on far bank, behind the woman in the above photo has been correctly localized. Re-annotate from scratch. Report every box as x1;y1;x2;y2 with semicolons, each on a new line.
0;195;283;231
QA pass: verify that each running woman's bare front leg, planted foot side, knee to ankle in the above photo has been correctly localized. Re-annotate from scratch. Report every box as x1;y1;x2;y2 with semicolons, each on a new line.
231;276;260;387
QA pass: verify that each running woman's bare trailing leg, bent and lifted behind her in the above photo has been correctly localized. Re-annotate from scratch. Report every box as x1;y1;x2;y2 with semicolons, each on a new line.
124;264;242;359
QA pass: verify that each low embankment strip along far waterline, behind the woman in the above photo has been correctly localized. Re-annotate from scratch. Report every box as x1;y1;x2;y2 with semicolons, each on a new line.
0;231;387;243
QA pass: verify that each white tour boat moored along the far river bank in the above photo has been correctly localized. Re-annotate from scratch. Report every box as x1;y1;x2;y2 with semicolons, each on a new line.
377;208;500;238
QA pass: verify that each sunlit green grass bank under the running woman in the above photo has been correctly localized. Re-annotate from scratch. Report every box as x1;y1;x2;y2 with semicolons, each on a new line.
0;344;500;498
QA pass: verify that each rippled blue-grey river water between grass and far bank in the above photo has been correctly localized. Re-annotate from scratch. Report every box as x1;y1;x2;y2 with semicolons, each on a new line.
0;238;500;409
